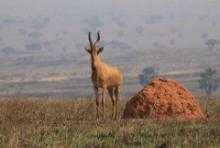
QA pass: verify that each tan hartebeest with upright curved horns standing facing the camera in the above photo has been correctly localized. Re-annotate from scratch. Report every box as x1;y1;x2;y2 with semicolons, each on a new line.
86;32;123;119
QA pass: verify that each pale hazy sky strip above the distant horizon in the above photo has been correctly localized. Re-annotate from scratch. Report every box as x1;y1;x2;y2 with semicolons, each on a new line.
0;0;220;16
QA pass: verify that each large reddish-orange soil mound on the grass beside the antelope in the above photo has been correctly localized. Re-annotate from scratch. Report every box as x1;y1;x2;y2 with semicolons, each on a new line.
123;78;205;120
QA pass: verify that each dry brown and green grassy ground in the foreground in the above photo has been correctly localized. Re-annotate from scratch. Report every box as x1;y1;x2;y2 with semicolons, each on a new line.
0;97;220;148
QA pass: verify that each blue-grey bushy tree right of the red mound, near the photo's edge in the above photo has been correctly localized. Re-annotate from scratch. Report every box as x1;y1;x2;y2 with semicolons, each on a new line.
199;68;220;97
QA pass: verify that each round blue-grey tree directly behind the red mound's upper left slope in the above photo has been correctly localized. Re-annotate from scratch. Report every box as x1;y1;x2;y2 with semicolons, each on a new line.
138;67;158;85
